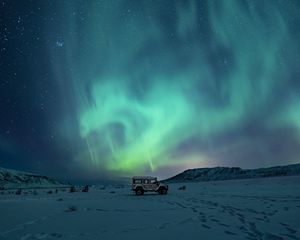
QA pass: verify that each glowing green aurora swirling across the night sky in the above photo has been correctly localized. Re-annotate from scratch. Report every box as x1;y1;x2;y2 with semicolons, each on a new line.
45;0;300;176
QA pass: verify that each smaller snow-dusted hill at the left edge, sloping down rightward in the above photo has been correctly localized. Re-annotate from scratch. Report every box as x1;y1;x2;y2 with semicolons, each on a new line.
0;168;64;189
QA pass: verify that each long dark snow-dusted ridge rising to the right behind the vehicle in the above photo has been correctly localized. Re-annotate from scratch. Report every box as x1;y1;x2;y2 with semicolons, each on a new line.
165;164;300;182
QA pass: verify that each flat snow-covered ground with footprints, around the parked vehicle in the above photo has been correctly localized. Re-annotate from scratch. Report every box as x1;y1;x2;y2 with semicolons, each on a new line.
0;176;300;240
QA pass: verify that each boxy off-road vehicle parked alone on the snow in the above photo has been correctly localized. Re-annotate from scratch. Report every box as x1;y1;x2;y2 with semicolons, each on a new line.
131;176;168;195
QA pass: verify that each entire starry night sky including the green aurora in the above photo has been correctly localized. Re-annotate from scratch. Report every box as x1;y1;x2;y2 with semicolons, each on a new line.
0;0;300;179
